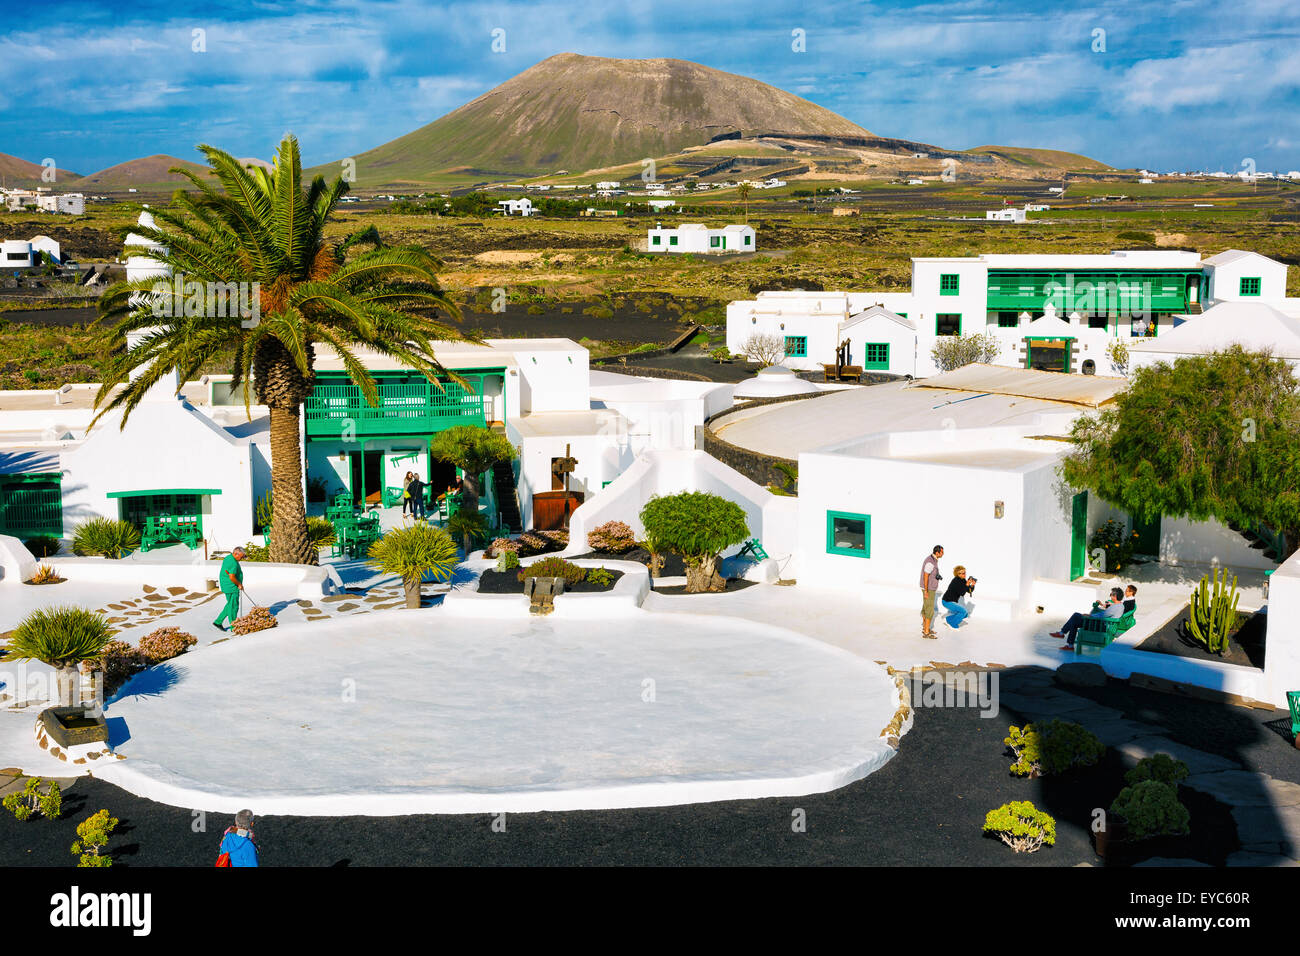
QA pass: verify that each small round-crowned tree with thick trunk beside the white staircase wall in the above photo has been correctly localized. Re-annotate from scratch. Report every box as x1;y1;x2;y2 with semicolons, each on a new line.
641;492;749;593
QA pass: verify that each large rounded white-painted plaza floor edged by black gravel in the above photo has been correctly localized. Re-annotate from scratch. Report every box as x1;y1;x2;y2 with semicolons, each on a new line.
96;609;897;816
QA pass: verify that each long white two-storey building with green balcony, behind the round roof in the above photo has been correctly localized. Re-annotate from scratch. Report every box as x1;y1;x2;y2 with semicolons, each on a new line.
727;250;1300;377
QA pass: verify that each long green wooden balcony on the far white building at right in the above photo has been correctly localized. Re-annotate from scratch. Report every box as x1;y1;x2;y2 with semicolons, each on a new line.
988;269;1201;315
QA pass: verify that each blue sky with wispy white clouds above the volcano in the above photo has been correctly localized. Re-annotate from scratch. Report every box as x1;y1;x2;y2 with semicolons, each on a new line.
0;0;1300;173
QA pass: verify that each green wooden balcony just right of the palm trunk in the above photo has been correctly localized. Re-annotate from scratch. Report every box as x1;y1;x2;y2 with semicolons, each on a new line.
304;375;491;437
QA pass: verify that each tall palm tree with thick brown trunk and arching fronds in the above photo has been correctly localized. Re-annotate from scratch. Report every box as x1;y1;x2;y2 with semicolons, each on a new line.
95;137;463;564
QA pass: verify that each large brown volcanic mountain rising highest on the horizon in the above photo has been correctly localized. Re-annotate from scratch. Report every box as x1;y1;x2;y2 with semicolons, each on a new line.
312;53;871;186
